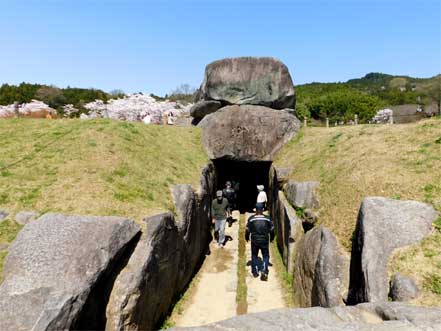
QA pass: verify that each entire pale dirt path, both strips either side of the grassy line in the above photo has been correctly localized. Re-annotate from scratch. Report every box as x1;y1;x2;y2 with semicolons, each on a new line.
172;212;286;327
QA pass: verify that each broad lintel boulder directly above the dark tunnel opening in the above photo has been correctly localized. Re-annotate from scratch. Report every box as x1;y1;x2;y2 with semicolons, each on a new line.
199;105;300;161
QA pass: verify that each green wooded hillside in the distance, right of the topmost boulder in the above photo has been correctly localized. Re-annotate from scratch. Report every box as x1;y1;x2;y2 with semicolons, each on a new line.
296;72;441;122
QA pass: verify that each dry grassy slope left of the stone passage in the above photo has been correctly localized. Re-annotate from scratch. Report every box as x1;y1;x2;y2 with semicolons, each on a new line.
0;119;208;280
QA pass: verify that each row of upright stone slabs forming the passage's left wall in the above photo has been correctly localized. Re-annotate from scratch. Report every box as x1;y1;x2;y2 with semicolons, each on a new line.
106;164;215;331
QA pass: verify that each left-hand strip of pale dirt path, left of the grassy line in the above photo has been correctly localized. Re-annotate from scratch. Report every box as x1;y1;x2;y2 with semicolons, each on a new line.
175;213;239;327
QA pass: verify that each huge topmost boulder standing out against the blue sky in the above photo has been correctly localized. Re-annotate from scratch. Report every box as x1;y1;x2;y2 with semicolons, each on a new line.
197;57;295;109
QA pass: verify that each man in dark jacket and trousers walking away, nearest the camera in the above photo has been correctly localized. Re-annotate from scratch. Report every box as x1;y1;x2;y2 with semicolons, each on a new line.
245;203;274;281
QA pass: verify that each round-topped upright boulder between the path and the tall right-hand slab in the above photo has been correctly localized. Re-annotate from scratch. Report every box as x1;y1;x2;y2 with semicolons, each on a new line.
293;226;349;307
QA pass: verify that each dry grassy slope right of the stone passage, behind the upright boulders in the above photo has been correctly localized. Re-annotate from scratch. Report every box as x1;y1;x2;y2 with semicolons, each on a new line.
276;119;441;305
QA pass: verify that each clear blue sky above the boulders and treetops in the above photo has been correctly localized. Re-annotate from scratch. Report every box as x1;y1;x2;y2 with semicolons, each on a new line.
0;0;441;95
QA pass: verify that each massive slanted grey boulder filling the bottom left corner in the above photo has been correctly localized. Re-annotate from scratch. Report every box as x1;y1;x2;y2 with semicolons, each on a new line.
0;214;140;331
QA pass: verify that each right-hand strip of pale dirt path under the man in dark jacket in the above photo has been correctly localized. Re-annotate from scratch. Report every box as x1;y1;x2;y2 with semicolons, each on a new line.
246;213;286;313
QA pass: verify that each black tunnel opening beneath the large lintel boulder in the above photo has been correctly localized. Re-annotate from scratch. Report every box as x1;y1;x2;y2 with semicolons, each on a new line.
213;159;271;213
